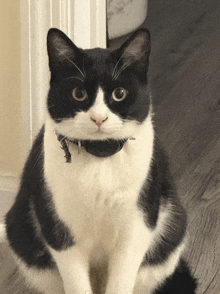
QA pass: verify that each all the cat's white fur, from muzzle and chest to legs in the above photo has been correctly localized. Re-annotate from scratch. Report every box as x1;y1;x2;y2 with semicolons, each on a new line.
12;94;185;294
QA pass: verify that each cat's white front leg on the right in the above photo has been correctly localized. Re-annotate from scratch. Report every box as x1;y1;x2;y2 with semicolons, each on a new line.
105;216;151;294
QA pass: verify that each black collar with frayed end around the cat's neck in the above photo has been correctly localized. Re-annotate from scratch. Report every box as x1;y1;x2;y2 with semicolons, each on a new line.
57;135;128;162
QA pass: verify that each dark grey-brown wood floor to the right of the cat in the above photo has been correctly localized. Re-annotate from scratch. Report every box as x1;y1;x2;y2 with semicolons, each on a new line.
113;0;220;294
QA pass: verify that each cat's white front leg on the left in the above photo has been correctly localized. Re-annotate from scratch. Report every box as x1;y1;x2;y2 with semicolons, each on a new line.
52;245;92;294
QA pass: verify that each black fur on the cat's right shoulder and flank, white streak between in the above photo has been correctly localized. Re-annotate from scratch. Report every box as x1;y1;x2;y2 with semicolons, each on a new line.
138;138;186;265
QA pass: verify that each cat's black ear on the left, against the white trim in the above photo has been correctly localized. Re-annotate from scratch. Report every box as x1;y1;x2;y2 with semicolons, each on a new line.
47;28;83;71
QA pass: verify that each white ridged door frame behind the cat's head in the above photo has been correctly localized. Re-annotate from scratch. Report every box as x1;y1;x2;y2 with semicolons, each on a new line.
20;0;107;158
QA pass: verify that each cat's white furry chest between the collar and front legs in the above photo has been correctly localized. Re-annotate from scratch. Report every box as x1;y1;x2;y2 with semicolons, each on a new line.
44;118;152;247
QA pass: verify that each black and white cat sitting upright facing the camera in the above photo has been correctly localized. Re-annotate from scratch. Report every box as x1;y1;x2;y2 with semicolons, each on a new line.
6;29;195;294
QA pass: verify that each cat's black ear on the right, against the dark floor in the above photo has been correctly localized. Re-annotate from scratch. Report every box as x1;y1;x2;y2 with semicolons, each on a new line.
112;29;151;78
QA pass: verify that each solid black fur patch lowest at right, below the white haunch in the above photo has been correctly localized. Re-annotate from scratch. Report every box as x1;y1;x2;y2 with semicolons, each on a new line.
155;260;197;294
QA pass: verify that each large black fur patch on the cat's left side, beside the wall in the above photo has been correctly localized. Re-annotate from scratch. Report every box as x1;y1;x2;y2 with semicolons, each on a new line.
6;128;74;268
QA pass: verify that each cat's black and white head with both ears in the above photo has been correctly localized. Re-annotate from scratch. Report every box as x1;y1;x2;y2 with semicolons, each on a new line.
47;29;150;140
